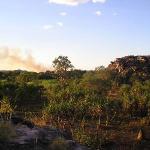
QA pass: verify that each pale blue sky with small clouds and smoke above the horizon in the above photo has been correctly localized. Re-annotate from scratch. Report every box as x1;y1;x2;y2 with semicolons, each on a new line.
0;0;150;71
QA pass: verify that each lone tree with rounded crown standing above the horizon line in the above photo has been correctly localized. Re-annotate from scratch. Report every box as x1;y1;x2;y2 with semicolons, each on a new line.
53;56;73;79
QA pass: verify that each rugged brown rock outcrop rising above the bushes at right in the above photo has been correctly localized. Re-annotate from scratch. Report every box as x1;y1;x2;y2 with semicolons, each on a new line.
108;55;150;80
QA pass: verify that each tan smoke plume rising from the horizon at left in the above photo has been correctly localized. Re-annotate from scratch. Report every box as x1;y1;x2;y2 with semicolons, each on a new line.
0;47;47;72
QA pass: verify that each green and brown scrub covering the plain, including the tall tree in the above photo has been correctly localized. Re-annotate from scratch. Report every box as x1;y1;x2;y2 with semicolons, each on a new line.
0;56;150;150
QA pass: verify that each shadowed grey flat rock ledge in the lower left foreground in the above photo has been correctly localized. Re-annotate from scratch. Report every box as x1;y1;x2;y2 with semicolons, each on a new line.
0;124;88;150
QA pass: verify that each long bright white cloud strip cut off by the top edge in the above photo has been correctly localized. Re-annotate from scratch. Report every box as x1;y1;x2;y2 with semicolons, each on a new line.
48;0;106;6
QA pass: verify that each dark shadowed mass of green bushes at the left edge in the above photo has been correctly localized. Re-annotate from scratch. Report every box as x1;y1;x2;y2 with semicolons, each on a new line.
0;81;46;111
